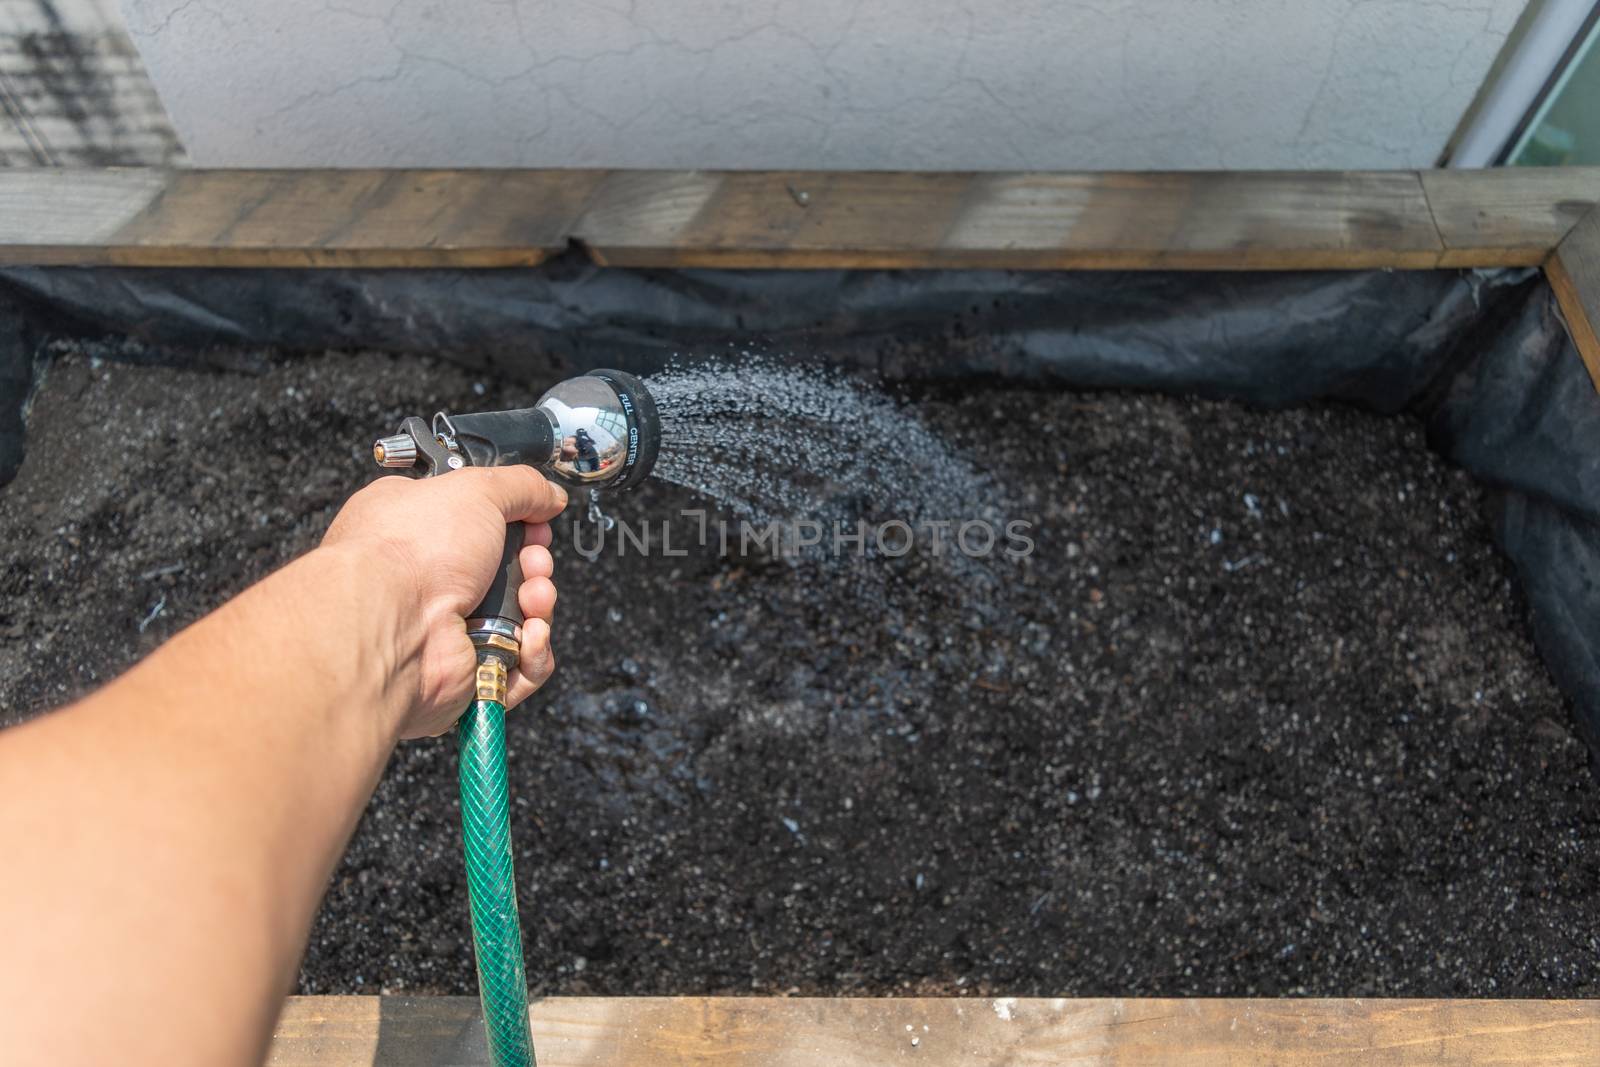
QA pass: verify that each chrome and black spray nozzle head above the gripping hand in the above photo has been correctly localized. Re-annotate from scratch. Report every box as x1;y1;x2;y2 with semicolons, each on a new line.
373;371;661;490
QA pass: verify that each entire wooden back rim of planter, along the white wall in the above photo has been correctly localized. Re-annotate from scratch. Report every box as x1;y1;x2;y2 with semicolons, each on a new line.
0;168;1600;270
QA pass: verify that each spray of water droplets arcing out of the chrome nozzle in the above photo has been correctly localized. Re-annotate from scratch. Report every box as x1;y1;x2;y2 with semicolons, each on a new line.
636;363;1010;736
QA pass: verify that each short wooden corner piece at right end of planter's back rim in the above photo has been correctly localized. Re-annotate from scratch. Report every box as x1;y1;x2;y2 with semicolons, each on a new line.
1422;166;1600;267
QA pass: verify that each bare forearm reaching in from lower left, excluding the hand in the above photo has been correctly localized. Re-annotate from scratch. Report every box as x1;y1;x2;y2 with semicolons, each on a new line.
0;549;421;1062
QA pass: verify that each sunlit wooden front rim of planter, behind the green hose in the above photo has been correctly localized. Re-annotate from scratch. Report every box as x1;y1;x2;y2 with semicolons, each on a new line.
267;997;1600;1067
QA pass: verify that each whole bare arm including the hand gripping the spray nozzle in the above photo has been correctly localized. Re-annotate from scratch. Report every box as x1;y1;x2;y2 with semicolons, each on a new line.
0;467;566;1064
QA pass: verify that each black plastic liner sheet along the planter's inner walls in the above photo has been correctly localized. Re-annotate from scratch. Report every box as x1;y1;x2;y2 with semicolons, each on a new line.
0;256;1600;752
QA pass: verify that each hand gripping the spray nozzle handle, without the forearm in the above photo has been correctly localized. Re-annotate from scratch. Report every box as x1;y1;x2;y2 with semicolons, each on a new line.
322;467;566;737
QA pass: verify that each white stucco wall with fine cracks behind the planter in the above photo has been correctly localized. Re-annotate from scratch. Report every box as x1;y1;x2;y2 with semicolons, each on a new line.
123;0;1525;170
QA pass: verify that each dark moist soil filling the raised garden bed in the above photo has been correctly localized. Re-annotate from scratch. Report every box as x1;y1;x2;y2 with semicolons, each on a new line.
0;355;1600;997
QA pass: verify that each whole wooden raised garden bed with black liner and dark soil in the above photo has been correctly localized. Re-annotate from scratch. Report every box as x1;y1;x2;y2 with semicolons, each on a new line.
0;173;1600;1062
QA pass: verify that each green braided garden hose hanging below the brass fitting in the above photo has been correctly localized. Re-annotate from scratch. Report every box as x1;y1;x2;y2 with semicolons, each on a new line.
459;701;533;1067
